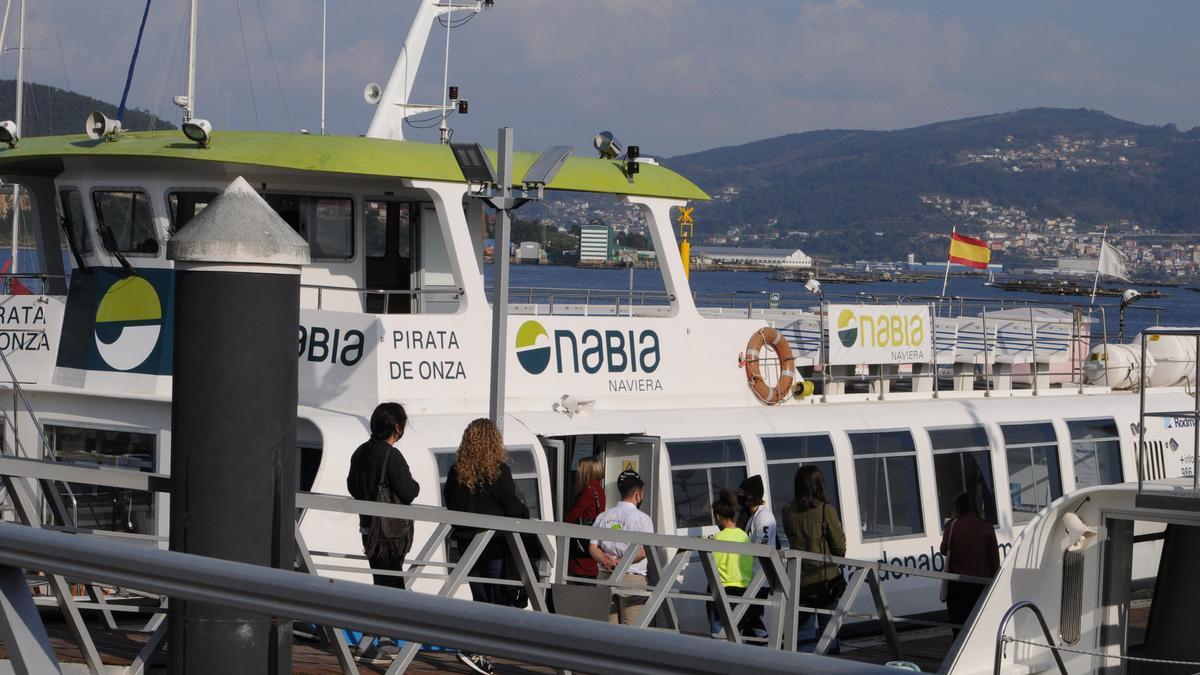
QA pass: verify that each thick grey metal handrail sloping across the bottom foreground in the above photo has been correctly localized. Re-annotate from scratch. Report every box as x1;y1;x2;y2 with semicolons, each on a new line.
0;524;902;675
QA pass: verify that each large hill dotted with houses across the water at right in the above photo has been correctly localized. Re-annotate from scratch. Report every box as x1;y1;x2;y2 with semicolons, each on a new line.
665;108;1200;259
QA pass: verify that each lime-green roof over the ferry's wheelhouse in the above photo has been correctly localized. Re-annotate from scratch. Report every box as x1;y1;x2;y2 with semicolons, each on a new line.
0;131;708;199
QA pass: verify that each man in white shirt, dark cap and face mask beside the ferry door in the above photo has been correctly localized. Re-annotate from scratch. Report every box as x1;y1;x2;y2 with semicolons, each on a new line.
588;471;654;626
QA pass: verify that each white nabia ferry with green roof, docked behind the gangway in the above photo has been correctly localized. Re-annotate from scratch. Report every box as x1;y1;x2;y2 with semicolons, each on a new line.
0;0;1195;634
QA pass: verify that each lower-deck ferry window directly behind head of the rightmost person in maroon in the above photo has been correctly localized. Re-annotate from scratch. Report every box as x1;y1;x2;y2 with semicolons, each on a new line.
929;426;998;525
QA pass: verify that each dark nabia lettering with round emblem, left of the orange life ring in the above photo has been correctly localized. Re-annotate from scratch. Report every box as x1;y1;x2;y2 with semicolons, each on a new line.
515;321;662;375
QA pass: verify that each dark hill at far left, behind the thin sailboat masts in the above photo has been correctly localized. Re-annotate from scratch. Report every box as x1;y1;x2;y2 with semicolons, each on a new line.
0;79;175;136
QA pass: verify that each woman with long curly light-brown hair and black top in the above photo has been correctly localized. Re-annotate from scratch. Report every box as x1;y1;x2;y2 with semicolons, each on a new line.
442;418;529;673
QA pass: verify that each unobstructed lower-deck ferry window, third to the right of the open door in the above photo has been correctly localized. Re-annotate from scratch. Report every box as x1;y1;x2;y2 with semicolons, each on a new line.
850;431;925;540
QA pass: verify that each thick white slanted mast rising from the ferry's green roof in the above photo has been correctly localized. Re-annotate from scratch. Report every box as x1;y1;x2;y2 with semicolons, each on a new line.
367;0;478;141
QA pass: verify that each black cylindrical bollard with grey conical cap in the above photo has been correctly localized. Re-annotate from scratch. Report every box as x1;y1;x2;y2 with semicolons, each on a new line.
167;178;308;675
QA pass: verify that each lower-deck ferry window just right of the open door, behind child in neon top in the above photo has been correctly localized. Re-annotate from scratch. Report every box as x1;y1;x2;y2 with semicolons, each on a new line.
666;438;746;528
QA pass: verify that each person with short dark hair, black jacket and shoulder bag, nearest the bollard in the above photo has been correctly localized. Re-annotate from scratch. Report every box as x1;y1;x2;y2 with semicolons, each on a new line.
346;402;421;589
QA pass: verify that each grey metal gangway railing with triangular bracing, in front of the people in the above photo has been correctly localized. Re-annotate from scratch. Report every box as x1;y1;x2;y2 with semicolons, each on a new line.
0;458;991;673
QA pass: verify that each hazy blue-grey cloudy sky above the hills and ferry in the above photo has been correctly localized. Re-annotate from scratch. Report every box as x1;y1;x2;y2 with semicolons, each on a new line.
9;0;1200;156
